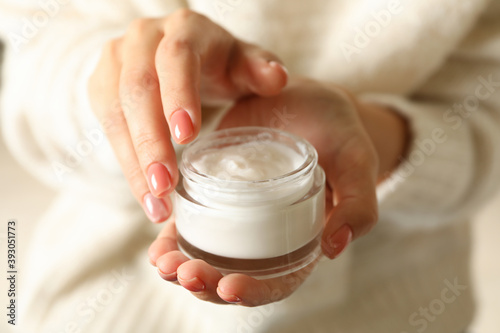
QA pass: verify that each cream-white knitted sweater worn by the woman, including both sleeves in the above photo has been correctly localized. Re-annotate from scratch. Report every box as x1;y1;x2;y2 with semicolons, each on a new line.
0;0;500;333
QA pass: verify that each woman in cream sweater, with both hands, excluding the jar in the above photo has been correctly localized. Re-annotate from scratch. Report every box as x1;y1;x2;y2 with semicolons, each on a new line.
2;0;500;332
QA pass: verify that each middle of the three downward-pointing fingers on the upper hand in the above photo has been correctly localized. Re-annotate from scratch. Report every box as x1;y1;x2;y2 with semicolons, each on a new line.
120;19;178;197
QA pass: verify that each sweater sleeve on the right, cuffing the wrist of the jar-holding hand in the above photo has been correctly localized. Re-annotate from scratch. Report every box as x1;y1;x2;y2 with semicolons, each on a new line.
370;9;500;229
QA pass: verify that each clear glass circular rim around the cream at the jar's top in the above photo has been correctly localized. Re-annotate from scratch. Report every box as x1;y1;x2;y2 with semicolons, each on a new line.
180;126;318;192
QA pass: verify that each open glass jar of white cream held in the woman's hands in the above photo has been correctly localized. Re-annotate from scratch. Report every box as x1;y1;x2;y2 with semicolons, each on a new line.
174;127;325;279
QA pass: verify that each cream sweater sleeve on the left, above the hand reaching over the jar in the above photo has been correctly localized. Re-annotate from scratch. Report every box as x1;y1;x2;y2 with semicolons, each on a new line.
0;0;183;188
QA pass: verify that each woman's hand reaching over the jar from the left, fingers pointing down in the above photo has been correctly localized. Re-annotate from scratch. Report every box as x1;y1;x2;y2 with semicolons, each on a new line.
88;9;287;222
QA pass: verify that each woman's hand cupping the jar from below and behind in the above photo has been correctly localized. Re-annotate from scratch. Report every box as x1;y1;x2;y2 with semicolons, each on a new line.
149;80;408;306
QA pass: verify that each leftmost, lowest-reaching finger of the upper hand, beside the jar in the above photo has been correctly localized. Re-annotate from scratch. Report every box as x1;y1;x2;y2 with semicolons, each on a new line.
91;40;172;222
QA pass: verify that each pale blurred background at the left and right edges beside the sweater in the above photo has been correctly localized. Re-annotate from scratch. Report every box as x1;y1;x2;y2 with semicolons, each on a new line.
0;39;500;333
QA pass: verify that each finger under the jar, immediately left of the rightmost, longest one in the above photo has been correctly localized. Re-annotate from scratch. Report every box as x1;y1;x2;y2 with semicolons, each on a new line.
177;259;225;303
